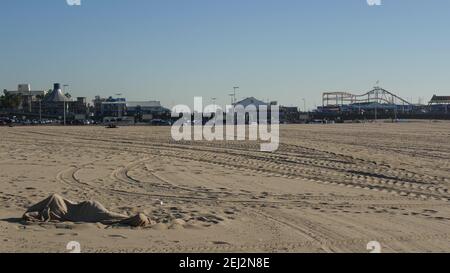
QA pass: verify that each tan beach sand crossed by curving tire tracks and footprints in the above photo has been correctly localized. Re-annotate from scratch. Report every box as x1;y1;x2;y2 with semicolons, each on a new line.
0;121;450;252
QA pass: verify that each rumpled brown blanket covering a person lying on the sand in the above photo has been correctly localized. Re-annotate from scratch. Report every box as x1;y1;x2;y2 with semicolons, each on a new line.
22;194;151;227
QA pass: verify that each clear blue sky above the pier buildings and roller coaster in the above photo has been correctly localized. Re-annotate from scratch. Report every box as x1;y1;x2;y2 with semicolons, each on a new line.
0;0;450;107
